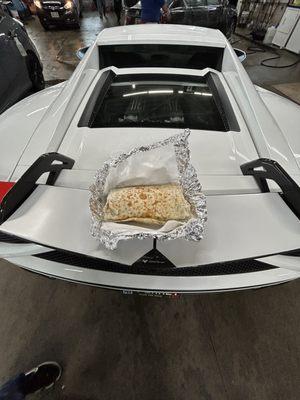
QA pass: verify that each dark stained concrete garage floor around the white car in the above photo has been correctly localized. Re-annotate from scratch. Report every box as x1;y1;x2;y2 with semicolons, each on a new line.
0;13;300;400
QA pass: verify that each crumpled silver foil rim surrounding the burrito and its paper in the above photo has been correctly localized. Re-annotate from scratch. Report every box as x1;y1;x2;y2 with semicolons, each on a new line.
90;129;207;250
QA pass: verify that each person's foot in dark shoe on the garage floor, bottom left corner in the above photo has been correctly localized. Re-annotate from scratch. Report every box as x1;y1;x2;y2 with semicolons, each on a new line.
0;361;62;400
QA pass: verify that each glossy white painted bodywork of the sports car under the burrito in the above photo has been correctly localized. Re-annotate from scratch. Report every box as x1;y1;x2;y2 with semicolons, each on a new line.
0;25;300;292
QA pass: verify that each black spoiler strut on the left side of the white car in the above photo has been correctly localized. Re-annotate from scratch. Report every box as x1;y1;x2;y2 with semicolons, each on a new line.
0;153;74;225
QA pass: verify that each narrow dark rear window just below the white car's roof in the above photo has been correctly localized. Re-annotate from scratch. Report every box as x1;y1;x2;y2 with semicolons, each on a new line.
99;44;223;71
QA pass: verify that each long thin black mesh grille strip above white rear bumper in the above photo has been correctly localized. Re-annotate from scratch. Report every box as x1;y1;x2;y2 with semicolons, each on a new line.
33;250;277;276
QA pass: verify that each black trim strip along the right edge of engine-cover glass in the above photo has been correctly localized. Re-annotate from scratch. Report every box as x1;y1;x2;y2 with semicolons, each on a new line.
207;72;240;132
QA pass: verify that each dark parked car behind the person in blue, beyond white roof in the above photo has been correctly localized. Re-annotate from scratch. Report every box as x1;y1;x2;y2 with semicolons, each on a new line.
123;0;237;37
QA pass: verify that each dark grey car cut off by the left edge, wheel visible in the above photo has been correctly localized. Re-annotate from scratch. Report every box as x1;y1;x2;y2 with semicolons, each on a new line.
0;6;45;113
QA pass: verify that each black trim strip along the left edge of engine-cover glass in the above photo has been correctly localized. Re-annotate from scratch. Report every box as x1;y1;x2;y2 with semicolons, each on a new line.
78;69;116;128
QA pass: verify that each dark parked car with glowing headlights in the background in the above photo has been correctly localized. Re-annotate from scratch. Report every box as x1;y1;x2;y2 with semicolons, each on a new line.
34;0;81;30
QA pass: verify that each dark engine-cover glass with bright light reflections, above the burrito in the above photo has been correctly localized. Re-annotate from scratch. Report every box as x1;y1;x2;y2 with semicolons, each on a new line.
91;76;228;131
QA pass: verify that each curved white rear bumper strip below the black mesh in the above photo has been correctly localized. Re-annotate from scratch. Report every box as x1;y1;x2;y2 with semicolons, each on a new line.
7;256;300;294
